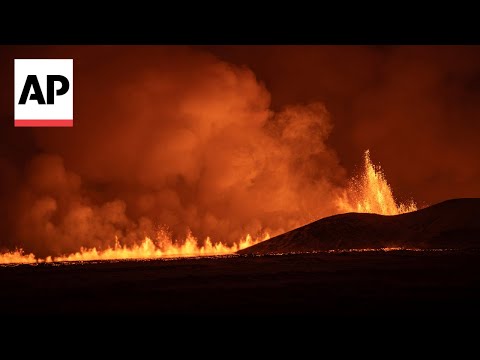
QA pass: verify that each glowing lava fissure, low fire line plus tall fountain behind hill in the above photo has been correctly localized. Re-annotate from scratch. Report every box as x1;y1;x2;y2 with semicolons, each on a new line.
0;150;417;264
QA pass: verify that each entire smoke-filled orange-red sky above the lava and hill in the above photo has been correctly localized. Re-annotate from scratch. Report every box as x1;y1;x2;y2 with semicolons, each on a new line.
0;46;480;250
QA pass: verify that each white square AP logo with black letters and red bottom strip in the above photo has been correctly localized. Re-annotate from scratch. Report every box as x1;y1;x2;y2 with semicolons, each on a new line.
14;59;73;127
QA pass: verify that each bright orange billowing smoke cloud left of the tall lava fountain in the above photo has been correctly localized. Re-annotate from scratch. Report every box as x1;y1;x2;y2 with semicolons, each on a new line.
3;47;346;256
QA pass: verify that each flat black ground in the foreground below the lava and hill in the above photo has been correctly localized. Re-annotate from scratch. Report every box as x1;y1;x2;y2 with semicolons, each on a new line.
0;251;480;316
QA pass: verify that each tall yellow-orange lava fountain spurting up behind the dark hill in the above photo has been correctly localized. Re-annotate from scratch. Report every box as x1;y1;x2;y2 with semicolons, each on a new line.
337;150;417;215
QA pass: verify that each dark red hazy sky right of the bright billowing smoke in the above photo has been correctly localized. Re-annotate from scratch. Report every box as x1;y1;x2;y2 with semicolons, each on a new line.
208;46;480;205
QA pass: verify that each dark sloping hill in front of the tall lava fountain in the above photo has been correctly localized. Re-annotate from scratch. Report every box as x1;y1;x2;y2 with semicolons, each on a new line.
239;198;480;254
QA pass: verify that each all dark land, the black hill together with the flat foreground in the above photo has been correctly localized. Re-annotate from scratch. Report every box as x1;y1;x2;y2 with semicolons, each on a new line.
0;199;480;316
